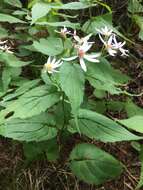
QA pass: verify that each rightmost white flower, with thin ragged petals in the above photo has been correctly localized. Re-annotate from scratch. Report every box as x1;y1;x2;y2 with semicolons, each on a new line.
113;35;129;56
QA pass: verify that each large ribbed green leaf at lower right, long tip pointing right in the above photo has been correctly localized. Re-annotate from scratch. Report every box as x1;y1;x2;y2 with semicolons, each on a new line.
69;109;142;142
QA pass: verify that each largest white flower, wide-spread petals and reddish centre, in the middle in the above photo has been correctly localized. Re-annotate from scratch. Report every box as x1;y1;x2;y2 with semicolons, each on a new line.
63;42;100;72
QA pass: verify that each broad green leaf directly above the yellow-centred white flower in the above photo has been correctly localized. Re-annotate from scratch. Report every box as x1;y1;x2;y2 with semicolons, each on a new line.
33;37;63;56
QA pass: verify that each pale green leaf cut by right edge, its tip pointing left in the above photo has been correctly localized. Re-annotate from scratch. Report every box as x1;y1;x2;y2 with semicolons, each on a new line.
119;115;143;133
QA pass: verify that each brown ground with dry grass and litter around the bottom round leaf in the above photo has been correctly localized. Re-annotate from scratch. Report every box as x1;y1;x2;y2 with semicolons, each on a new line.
0;136;140;190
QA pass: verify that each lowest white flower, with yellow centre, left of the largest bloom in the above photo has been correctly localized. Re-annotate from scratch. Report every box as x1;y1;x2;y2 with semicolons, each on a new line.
44;57;63;74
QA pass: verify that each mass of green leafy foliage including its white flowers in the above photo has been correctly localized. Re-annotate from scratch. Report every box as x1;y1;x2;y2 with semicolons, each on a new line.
0;0;143;187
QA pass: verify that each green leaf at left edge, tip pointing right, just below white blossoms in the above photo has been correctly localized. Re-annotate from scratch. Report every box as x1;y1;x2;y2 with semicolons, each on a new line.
0;52;31;67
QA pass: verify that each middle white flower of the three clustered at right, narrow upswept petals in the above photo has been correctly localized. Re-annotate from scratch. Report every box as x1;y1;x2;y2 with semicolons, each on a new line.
99;34;117;56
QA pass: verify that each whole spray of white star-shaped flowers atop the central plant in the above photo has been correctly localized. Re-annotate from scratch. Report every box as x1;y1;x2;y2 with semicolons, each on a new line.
44;26;128;74
